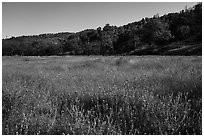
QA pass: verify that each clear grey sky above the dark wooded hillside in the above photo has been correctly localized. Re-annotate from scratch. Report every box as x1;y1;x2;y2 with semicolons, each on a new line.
2;2;196;38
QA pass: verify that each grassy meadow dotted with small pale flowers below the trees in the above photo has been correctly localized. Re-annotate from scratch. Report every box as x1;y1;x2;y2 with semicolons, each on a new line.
2;56;202;135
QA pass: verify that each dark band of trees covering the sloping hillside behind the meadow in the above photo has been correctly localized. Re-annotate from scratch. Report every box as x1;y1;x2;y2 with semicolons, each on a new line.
2;3;202;56
